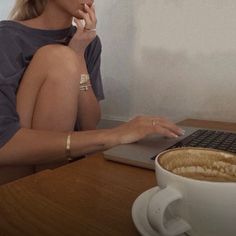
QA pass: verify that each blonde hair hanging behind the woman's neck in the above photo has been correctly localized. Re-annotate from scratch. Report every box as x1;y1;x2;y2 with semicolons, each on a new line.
8;0;47;21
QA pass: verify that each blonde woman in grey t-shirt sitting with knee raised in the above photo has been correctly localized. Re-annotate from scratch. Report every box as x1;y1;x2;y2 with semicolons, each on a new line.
0;0;182;183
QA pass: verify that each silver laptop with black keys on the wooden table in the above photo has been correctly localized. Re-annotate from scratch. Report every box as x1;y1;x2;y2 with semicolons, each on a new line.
104;126;236;169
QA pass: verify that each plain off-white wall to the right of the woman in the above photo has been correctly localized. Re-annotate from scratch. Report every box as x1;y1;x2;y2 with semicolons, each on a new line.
96;0;236;121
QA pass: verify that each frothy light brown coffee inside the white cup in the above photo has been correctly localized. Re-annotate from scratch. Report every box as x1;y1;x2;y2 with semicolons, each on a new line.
158;148;236;182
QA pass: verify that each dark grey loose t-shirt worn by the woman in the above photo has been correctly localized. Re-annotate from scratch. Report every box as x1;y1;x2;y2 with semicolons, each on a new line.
0;21;104;147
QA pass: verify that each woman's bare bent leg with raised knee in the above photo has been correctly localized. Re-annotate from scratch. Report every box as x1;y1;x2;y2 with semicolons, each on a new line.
17;45;86;131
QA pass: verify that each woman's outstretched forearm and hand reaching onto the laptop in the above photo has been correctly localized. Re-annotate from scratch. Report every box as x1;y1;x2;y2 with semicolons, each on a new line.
0;116;183;166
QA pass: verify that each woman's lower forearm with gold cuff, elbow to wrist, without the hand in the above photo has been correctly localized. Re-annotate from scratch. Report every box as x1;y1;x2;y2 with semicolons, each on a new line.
0;129;116;166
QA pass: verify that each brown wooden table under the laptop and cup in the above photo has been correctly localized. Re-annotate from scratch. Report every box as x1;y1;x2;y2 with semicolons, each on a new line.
0;119;236;236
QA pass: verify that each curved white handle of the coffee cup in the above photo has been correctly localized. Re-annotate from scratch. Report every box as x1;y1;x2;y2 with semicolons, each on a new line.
147;186;191;236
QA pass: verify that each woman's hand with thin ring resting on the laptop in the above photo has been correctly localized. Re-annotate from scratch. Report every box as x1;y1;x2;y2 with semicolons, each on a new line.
111;116;184;145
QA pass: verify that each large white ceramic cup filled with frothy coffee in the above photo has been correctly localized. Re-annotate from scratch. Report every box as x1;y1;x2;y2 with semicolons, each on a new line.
147;148;236;236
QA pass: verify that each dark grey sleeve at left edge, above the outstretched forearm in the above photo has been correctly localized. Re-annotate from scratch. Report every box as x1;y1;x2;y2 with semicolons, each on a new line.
0;30;21;148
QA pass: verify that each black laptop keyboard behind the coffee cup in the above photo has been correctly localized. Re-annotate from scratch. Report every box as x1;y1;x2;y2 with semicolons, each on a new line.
151;129;236;160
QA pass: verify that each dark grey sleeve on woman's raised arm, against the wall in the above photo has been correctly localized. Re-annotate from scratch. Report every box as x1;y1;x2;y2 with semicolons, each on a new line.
85;36;104;101
